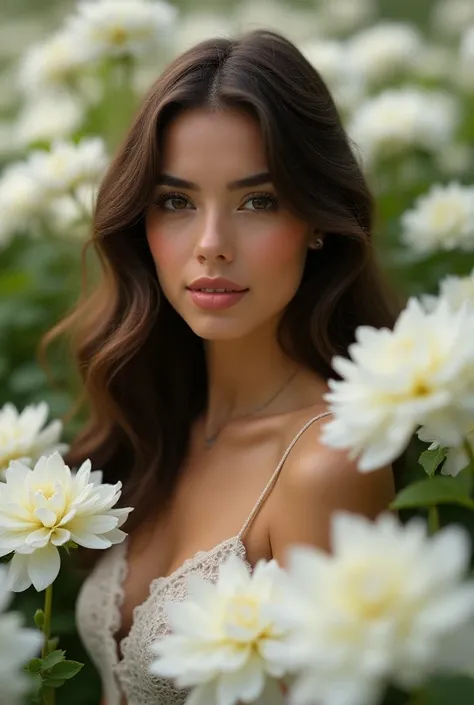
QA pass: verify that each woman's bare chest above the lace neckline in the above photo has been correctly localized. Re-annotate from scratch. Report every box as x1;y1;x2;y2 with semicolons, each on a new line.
117;432;278;639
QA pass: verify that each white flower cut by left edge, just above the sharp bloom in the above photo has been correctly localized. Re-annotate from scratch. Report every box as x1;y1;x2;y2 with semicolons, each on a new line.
0;402;69;477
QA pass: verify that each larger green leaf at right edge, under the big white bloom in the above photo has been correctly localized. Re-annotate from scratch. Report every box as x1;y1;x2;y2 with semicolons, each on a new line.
390;475;474;510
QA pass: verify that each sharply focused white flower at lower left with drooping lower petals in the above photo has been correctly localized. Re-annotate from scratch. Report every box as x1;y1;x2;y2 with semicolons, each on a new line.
0;452;131;592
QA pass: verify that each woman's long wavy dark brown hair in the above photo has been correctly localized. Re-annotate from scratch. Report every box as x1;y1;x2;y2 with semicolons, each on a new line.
40;30;400;552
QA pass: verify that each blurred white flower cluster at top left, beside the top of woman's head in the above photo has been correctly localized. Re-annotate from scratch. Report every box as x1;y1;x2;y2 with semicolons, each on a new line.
20;0;177;95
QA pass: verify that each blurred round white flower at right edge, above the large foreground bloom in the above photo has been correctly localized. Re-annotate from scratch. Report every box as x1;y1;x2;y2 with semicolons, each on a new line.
401;182;474;253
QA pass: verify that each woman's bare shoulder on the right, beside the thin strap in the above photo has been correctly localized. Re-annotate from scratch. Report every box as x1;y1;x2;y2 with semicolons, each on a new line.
269;412;395;564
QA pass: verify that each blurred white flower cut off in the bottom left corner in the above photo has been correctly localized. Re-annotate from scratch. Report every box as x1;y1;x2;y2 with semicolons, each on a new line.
0;566;43;705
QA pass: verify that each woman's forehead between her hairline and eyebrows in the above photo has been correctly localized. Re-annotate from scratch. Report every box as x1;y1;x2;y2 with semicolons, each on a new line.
161;109;268;183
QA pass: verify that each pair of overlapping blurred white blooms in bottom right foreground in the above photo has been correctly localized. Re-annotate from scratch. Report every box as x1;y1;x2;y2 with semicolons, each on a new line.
151;513;474;705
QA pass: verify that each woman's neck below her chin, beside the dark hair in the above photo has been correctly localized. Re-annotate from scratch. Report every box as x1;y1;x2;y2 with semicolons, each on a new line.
205;324;298;436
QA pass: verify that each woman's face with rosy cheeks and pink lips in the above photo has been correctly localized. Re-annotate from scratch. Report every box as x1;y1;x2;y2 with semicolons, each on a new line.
146;109;310;340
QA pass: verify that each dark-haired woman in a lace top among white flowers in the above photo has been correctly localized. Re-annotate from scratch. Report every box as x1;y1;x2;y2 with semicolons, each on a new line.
43;31;397;705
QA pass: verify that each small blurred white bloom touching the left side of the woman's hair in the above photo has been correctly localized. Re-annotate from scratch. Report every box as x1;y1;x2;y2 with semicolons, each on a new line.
49;184;97;239
